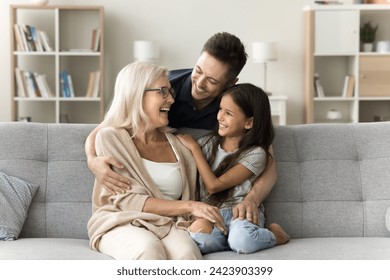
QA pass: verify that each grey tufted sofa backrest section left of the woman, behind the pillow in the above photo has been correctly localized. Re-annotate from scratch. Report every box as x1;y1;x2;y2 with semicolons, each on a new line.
0;122;96;239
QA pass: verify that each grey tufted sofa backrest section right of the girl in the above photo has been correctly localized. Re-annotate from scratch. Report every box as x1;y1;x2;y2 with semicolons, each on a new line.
265;122;390;238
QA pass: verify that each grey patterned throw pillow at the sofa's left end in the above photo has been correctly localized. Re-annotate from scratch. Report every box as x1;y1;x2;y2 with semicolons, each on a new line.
0;171;38;240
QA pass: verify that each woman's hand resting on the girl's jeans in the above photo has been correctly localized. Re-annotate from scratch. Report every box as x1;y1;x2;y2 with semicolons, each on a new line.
191;201;227;235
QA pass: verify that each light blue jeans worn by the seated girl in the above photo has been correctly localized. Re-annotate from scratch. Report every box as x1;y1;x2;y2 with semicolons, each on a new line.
190;208;276;254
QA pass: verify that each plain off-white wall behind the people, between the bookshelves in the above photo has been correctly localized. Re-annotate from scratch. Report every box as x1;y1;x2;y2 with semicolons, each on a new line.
0;0;322;124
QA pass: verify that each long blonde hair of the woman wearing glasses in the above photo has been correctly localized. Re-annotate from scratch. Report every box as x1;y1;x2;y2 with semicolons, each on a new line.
103;62;168;136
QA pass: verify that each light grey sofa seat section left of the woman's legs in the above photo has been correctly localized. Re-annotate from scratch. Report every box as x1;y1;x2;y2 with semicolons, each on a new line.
0;238;112;260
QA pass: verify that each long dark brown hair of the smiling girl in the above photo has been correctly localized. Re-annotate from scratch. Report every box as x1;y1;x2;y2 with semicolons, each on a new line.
207;83;275;205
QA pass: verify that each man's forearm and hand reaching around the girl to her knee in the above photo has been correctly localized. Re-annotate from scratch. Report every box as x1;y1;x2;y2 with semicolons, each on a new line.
233;146;277;224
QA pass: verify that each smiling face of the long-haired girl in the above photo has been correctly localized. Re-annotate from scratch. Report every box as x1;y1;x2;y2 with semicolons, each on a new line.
217;95;253;139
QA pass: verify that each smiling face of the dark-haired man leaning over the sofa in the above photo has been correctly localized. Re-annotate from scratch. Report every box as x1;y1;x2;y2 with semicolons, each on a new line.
191;52;234;103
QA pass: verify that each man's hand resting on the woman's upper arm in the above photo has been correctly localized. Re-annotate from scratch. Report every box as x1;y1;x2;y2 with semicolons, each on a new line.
88;156;130;194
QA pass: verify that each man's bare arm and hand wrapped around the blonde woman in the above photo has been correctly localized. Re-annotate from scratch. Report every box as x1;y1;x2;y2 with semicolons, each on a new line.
85;123;130;194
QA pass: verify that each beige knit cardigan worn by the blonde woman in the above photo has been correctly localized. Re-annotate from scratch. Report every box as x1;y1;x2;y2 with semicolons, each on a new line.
88;127;196;250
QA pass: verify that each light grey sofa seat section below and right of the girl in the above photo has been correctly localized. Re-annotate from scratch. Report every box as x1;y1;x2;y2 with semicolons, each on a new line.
204;237;390;260
